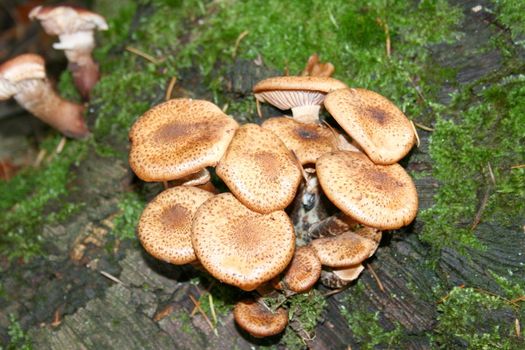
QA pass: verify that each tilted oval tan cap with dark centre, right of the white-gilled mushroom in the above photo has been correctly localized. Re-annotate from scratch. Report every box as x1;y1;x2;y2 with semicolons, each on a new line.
324;89;416;164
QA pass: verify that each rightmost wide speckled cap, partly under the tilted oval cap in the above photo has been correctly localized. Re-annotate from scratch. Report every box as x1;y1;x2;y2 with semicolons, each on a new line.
316;151;418;230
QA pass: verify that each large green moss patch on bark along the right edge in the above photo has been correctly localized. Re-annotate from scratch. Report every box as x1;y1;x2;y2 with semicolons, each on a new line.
420;76;525;249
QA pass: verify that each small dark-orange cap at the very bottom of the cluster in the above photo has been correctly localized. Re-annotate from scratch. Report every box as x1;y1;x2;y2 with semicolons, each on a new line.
233;300;288;338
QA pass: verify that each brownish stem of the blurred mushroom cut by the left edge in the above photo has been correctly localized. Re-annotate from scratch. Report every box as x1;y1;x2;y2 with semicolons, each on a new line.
14;79;89;139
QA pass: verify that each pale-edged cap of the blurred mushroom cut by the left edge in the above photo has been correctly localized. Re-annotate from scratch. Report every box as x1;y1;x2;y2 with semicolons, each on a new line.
0;53;46;100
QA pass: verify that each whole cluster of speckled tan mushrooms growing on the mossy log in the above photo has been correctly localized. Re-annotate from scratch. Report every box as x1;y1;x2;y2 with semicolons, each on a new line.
129;65;418;337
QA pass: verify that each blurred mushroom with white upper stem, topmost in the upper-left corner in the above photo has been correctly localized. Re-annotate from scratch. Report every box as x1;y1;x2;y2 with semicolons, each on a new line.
29;6;108;99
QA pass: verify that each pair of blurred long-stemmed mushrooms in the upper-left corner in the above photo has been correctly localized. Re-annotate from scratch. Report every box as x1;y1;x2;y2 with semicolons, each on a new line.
0;6;108;138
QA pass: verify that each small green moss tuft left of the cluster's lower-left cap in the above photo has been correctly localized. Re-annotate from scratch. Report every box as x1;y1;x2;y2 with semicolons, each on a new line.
111;192;146;239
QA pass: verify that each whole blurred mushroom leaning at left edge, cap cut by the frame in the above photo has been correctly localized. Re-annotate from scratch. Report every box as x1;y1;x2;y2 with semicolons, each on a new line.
0;54;89;139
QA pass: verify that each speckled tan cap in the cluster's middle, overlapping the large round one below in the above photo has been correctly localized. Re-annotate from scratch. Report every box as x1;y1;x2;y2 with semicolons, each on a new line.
216;124;301;213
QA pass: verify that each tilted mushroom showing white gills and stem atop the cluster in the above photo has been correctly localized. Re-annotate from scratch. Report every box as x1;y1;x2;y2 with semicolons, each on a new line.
253;76;347;123
